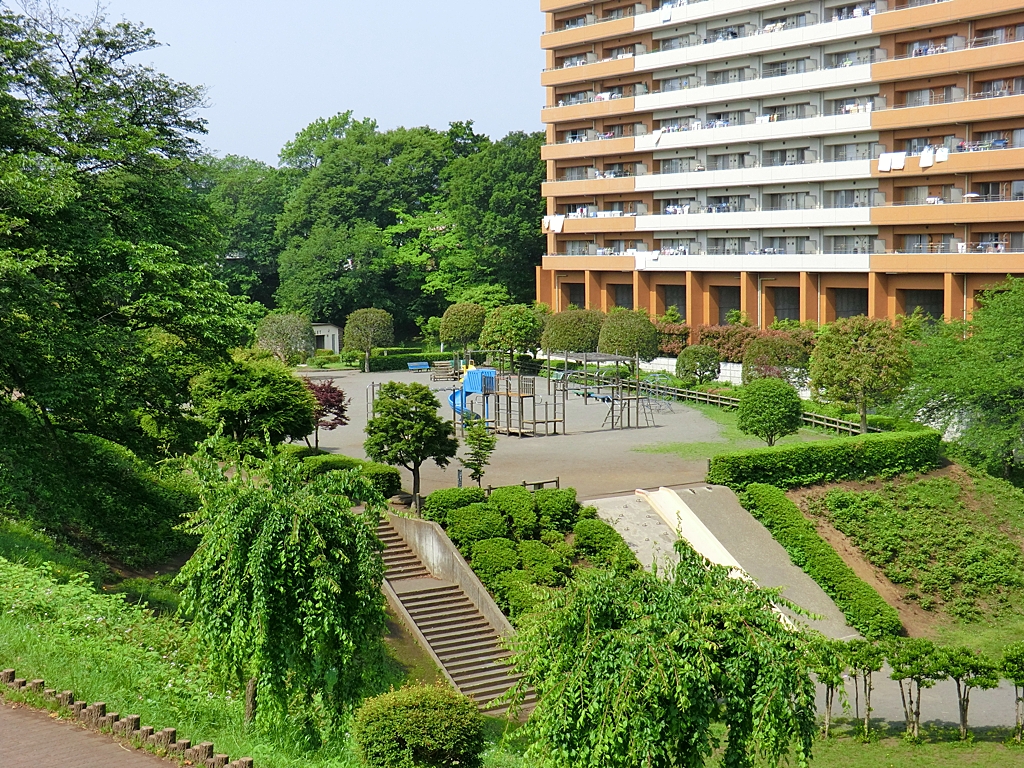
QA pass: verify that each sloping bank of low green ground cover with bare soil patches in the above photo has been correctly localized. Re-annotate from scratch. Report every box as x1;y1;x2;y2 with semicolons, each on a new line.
802;465;1024;657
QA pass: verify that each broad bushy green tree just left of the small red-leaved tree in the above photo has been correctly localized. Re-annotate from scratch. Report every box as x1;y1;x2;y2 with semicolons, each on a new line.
191;352;316;451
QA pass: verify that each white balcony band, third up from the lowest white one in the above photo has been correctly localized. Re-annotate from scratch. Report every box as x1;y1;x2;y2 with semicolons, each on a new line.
635;160;871;192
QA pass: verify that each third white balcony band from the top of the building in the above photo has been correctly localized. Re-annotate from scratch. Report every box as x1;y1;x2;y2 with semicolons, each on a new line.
634;65;871;113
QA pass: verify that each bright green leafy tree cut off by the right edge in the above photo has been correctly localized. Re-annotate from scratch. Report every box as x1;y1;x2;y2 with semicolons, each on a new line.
901;279;1024;477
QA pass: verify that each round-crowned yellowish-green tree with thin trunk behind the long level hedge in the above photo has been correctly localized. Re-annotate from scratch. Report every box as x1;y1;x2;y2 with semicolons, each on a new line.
811;315;911;433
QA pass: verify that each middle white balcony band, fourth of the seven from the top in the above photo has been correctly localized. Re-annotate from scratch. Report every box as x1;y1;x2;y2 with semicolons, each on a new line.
636;113;871;152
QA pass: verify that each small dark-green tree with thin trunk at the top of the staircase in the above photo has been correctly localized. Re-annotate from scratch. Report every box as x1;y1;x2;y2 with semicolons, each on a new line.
364;381;459;511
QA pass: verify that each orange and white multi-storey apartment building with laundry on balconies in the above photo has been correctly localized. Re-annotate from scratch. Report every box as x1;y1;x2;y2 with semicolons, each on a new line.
537;0;1024;326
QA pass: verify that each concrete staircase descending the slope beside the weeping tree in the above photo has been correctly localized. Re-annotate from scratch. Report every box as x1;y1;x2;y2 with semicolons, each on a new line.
377;519;535;715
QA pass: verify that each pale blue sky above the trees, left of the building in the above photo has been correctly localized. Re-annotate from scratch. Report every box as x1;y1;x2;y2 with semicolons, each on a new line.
51;0;544;164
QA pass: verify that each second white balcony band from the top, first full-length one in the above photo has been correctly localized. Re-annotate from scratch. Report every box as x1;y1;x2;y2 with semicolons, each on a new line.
635;16;871;72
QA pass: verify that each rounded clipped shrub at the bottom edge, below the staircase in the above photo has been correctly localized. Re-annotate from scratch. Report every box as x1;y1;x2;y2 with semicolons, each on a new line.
352;685;485;768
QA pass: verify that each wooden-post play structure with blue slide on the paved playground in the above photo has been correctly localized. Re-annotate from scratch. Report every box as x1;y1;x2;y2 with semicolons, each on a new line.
447;368;565;437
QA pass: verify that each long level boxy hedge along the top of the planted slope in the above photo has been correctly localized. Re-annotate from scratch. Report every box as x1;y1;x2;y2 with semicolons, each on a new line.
708;430;940;488
